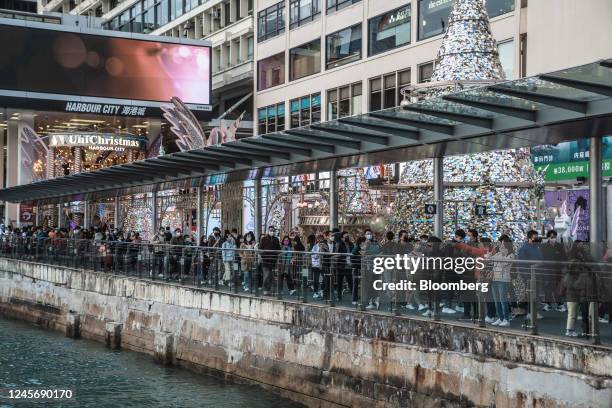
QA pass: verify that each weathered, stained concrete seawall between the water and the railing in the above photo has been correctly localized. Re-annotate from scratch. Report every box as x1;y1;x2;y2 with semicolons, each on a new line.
0;259;612;408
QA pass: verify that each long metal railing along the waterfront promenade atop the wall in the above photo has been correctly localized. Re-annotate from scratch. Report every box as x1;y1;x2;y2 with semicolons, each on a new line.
0;236;612;344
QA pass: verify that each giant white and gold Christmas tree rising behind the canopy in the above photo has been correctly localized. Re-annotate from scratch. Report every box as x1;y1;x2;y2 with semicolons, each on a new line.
389;0;542;240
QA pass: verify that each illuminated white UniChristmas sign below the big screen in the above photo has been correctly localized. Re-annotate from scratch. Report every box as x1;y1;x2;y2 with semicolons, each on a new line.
49;133;144;151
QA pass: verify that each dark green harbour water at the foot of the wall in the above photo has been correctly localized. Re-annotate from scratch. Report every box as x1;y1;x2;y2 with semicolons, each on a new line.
0;318;301;408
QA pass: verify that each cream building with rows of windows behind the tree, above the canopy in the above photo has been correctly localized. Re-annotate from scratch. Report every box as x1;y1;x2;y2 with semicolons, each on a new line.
254;0;612;134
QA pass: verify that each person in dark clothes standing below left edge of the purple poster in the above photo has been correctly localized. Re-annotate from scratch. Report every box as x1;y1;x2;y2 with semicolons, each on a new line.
540;230;567;312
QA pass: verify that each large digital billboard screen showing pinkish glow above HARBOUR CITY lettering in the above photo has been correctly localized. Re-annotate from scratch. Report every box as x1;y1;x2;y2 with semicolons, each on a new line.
0;24;211;115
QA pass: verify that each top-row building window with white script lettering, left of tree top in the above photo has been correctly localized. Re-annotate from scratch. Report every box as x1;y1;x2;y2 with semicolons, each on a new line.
368;4;411;56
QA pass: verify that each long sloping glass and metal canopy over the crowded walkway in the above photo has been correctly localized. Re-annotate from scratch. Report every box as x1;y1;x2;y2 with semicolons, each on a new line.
0;59;612;205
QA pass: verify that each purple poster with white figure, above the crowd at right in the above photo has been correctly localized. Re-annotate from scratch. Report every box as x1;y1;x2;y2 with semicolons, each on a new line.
544;189;590;242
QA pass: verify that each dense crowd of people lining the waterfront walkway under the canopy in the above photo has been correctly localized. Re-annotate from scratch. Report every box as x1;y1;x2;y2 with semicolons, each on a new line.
0;225;612;337
